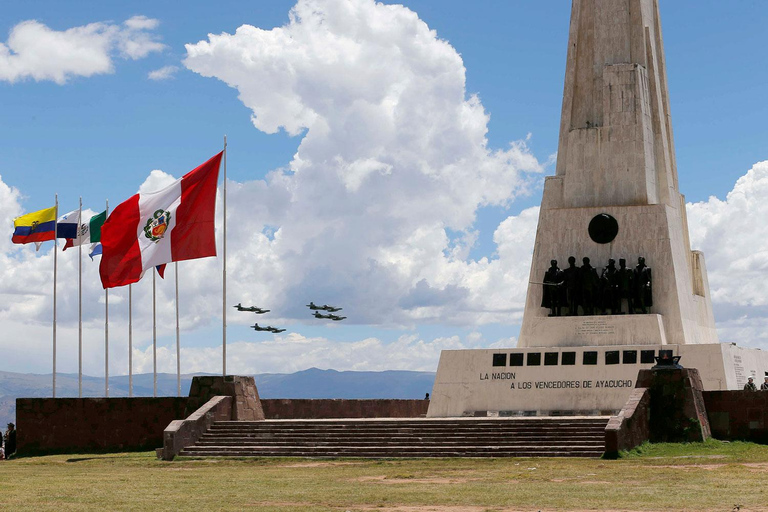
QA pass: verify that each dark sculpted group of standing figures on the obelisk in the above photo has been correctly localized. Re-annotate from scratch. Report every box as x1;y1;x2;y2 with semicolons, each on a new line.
541;256;653;316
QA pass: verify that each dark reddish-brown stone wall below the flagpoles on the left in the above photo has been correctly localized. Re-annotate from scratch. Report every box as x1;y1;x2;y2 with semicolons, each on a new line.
16;397;187;455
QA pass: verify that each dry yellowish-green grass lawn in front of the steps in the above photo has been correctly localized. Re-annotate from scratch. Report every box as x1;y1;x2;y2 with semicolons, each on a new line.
0;441;768;512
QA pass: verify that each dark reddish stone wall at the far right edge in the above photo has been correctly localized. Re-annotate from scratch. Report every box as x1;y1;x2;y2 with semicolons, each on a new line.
704;391;768;444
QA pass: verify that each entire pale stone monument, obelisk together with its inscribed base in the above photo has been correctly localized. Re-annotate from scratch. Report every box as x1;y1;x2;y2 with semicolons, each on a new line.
428;0;768;417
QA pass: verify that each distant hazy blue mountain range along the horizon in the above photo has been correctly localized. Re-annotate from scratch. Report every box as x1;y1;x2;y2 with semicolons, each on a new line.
0;368;435;430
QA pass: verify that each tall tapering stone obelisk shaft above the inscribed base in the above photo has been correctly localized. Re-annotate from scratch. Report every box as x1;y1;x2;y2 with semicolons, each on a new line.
518;0;717;347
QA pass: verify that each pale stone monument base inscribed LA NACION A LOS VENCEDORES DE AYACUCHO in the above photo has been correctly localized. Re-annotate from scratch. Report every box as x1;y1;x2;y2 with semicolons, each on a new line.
427;342;768;418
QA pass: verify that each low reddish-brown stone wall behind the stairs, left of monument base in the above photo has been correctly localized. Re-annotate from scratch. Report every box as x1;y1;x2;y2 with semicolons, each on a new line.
261;398;429;419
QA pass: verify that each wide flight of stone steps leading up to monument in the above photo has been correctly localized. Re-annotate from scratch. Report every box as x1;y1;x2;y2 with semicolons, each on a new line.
180;416;609;458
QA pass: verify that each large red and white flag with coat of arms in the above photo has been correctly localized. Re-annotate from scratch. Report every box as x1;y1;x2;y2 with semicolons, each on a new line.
99;151;224;289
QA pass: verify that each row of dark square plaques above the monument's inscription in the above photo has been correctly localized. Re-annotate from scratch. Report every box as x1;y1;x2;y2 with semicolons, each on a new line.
493;350;656;367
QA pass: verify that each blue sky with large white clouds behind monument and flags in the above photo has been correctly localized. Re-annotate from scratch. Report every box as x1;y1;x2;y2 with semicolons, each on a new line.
0;0;768;384
